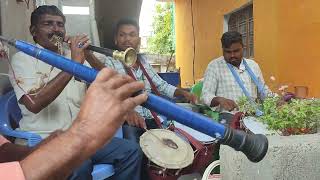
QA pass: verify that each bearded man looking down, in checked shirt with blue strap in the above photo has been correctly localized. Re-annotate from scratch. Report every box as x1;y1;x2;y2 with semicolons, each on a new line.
201;32;270;118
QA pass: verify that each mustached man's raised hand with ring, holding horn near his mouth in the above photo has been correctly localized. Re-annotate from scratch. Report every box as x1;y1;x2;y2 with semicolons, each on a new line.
65;34;91;63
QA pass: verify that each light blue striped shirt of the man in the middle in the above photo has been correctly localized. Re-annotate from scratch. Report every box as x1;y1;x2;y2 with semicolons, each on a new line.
95;53;177;119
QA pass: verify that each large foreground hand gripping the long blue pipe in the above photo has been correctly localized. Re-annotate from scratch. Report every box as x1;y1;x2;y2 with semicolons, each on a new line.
71;68;147;146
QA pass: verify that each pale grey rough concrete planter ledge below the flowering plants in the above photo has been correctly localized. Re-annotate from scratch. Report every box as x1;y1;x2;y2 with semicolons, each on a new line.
220;133;320;180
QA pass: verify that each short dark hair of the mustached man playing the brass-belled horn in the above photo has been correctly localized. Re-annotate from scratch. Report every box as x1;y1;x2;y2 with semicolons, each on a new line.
31;5;66;26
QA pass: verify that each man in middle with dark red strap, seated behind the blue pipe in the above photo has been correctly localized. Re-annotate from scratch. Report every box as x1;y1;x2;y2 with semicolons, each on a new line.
86;18;196;142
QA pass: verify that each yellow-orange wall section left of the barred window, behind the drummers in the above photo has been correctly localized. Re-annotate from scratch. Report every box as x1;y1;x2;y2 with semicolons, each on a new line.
175;0;252;87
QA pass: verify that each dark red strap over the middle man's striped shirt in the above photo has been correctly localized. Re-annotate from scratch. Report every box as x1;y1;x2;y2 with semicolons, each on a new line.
124;59;162;128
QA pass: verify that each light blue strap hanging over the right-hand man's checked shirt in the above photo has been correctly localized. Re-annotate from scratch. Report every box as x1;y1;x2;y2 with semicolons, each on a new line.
227;59;265;116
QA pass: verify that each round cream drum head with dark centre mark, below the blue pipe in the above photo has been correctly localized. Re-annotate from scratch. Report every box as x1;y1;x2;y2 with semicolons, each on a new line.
140;129;194;169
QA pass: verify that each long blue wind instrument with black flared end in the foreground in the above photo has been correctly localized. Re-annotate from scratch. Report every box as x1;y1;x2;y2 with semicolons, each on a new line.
0;36;268;162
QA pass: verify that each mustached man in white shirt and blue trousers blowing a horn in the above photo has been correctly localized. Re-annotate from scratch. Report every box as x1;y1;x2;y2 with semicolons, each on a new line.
10;6;142;180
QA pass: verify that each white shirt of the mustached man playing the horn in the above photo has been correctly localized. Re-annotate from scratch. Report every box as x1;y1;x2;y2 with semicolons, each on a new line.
9;45;86;138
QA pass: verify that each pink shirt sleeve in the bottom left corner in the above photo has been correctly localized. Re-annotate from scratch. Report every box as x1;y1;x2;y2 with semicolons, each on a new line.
0;135;25;180
